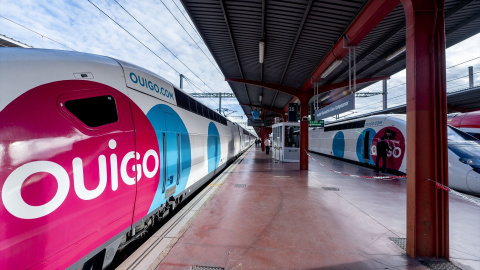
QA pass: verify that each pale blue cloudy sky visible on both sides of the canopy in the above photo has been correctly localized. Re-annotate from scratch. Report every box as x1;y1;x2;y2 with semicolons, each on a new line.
0;0;480;126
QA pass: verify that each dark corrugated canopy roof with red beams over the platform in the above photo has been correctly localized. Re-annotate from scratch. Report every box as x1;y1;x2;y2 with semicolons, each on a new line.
181;0;480;124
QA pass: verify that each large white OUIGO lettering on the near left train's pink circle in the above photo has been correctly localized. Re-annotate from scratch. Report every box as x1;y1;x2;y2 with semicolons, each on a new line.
2;139;160;219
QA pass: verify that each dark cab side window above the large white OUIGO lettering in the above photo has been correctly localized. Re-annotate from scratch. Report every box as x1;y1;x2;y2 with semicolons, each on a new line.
65;95;118;127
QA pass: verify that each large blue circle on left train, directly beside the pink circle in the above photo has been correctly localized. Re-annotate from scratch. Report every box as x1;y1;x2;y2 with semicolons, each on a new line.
147;104;192;213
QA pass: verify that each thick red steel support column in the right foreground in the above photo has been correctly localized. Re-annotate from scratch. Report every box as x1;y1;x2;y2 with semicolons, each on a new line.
402;0;449;259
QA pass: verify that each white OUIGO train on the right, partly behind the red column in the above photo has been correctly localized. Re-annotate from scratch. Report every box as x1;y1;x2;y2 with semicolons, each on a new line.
308;114;480;195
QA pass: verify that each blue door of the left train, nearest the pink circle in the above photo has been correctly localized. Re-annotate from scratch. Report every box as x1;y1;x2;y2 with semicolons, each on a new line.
163;112;180;198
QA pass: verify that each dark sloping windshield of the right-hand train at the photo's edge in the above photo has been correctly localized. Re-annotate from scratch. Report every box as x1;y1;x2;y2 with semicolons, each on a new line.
447;126;480;168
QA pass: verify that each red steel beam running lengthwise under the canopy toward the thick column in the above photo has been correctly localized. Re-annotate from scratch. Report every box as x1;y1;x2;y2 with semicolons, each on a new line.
302;0;400;91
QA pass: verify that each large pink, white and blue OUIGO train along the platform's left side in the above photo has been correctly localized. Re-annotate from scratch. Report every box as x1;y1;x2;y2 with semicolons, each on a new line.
0;48;255;269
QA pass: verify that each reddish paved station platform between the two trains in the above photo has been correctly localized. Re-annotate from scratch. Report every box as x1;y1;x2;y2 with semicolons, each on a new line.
120;147;480;270
